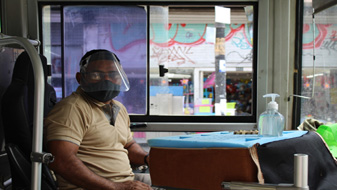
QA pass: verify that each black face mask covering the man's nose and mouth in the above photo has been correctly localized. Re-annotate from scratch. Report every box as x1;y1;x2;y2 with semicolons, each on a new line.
82;80;120;102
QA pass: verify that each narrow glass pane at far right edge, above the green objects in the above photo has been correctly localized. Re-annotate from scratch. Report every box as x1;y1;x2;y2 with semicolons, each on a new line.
301;0;337;123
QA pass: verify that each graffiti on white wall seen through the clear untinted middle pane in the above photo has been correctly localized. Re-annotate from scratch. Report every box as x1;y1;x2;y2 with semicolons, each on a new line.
150;23;252;67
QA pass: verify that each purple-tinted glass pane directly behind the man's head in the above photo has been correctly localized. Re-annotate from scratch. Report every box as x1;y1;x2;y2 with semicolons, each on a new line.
64;6;147;114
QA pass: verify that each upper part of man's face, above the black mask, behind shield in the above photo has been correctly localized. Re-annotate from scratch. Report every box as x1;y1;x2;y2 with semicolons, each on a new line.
84;60;121;85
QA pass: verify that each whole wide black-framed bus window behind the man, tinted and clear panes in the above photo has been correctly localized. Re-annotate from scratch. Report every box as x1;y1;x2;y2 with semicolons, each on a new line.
41;2;257;131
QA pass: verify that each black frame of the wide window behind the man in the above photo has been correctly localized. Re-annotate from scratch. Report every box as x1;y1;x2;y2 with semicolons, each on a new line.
38;0;259;131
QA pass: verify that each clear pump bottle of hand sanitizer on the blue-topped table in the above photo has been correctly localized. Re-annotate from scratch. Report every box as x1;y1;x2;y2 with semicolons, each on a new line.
258;94;284;137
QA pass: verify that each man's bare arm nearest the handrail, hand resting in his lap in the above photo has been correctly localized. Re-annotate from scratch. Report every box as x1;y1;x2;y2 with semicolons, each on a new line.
48;140;151;190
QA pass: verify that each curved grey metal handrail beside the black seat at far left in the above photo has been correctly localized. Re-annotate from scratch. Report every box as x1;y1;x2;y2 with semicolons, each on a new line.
0;34;45;190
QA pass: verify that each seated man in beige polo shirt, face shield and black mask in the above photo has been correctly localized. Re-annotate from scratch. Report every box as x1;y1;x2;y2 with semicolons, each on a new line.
44;50;151;190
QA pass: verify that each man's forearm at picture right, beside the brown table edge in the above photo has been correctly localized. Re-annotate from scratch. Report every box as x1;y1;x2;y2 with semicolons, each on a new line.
124;140;150;166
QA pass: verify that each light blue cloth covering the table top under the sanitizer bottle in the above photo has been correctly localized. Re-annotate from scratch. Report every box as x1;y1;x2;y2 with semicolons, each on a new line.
148;131;308;148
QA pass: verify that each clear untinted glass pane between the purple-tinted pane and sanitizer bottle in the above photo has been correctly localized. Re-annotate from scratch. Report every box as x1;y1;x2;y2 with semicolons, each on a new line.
150;6;253;116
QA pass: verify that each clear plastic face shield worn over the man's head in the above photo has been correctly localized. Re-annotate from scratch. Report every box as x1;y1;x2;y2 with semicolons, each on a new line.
80;50;130;92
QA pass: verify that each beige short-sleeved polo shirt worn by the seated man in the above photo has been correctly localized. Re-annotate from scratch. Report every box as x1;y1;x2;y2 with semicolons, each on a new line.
44;87;134;189
